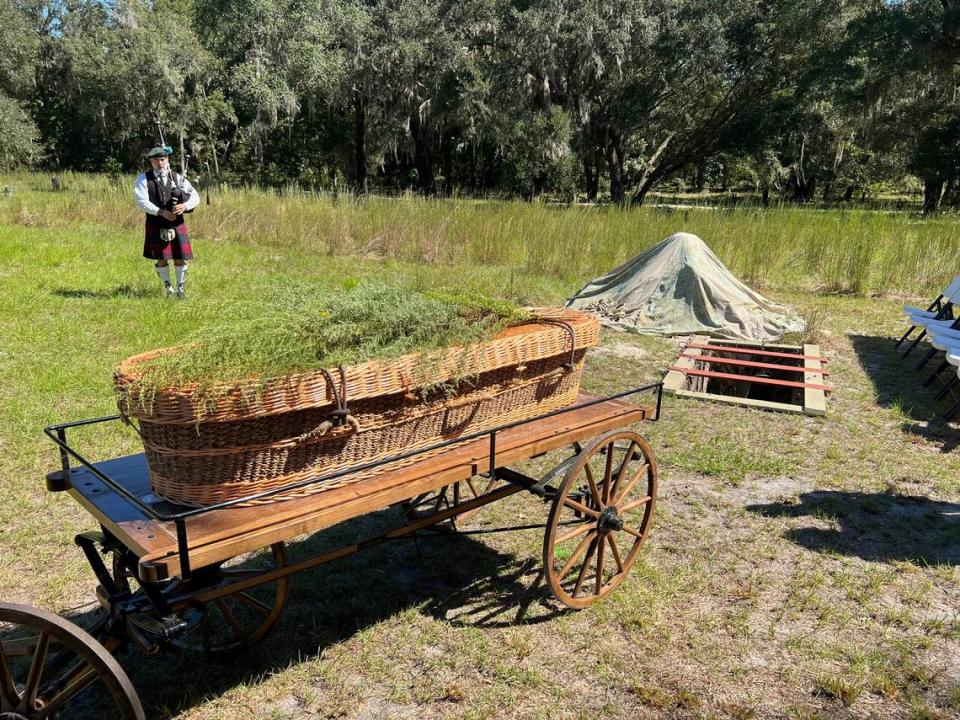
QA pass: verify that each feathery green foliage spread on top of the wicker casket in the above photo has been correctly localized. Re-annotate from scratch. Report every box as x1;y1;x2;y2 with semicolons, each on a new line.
129;283;527;400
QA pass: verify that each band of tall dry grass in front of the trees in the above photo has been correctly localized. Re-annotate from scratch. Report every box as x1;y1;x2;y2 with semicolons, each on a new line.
0;173;960;294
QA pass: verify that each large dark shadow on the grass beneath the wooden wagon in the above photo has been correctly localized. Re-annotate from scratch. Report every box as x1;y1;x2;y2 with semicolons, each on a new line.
0;510;569;718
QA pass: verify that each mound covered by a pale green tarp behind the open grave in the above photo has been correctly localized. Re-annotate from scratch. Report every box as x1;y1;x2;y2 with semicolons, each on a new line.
567;233;804;342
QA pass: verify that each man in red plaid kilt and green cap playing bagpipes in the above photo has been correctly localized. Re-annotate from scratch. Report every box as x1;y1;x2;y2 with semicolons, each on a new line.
133;134;200;298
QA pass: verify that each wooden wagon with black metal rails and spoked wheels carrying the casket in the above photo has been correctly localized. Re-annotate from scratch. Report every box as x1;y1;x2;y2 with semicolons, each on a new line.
0;383;662;720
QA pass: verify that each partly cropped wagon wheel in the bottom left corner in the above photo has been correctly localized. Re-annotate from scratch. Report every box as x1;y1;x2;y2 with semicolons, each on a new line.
0;603;144;720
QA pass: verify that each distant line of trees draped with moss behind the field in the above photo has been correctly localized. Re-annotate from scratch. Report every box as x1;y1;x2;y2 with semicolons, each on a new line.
0;0;960;213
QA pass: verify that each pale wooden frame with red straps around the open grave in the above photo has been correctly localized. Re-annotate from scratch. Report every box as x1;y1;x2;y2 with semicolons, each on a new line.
663;335;827;415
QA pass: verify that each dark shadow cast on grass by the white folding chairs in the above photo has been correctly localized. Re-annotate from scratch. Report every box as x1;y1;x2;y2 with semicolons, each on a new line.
850;331;960;453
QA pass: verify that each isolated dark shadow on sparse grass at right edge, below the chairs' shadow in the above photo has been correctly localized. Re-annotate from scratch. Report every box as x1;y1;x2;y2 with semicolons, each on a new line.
747;490;960;565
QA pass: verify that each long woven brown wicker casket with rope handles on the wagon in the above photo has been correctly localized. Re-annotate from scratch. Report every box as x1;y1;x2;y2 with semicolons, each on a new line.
114;308;600;507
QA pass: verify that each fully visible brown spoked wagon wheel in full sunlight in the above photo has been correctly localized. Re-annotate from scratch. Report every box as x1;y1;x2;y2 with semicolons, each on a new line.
543;430;657;608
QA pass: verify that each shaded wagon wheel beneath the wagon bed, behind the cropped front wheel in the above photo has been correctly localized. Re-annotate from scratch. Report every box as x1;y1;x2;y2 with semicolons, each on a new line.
173;542;290;655
